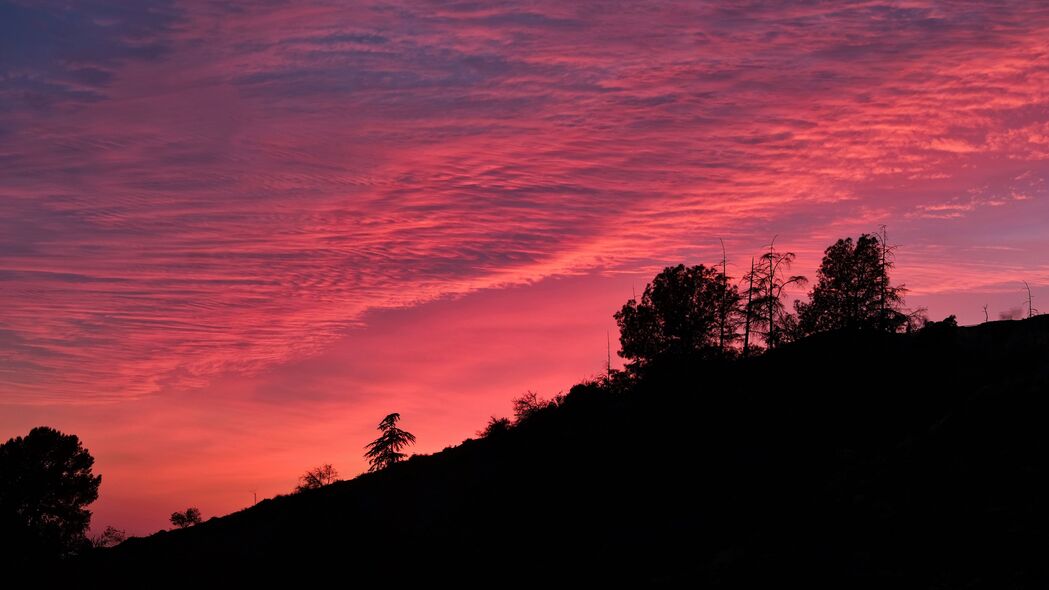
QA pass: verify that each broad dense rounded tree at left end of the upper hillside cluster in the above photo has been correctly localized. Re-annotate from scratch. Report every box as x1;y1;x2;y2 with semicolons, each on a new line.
615;265;740;367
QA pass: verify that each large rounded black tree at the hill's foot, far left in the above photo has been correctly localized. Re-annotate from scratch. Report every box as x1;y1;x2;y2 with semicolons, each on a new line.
0;426;102;556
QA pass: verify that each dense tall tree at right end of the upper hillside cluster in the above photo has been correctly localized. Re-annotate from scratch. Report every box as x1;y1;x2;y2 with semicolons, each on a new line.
795;234;908;334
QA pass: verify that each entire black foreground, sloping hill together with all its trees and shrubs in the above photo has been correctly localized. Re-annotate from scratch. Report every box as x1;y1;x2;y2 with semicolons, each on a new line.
0;229;1049;589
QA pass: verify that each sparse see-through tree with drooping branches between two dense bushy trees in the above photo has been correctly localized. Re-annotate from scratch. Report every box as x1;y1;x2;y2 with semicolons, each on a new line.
744;237;809;352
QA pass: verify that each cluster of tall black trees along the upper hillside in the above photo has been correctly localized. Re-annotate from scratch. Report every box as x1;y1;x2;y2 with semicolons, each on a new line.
615;234;926;371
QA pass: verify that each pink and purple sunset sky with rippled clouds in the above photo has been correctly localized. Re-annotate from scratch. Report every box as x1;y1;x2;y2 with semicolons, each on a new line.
0;0;1049;534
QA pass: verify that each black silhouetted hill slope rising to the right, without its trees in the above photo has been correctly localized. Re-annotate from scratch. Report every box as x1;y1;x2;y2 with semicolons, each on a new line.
69;316;1049;588
